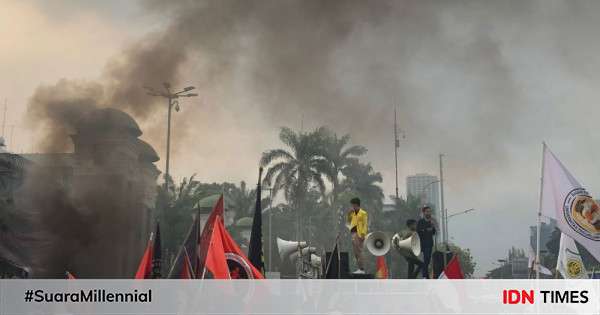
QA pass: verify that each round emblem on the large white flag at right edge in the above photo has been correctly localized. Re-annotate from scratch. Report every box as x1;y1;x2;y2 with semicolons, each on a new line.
563;188;600;241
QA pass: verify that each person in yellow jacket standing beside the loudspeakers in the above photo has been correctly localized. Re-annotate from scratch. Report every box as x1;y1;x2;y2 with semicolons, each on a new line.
348;198;369;274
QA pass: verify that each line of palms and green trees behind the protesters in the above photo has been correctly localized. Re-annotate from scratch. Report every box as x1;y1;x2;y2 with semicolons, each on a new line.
156;127;474;276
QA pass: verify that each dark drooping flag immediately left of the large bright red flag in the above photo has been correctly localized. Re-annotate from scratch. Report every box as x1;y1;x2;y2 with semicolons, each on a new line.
168;212;200;279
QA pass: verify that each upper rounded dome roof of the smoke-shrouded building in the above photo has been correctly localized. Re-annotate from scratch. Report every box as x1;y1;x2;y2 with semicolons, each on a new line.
77;108;142;137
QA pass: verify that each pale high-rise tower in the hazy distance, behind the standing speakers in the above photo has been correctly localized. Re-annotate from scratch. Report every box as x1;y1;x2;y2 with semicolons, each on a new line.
406;173;440;217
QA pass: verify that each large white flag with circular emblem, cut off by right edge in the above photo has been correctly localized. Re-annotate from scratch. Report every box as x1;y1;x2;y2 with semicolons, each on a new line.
540;144;600;260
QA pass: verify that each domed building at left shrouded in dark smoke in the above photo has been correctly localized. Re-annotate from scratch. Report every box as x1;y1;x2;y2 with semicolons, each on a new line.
12;108;160;278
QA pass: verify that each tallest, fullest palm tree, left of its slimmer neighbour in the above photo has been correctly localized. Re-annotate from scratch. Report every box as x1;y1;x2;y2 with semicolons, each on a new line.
260;127;330;239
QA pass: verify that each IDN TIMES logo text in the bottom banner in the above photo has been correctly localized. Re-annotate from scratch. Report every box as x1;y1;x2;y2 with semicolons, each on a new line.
502;289;590;304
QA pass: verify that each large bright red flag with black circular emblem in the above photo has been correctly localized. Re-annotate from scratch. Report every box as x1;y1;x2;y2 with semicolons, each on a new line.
198;196;264;279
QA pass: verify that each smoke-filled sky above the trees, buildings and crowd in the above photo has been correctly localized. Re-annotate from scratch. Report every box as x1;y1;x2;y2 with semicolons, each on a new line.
0;0;600;275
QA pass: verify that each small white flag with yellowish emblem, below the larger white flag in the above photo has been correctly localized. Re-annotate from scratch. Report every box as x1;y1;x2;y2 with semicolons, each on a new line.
556;233;588;279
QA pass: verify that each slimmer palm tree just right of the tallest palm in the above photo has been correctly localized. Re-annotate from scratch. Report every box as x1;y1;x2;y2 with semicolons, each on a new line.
325;133;367;208
